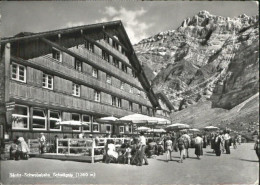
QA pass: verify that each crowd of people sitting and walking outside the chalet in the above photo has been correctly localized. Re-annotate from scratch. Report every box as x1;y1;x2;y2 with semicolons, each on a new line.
10;130;260;163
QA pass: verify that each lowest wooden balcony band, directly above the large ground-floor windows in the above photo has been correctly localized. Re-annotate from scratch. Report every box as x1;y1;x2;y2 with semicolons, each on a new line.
10;81;136;117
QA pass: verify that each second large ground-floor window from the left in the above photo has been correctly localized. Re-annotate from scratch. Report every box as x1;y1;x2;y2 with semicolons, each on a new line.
32;108;46;130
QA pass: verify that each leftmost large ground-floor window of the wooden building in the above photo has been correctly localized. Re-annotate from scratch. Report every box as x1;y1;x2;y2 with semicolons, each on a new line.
12;105;29;129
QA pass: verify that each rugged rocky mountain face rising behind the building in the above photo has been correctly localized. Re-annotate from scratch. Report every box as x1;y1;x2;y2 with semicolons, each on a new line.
134;11;259;111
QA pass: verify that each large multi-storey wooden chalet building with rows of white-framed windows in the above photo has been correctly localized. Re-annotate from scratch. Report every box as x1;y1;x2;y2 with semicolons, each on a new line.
0;21;171;139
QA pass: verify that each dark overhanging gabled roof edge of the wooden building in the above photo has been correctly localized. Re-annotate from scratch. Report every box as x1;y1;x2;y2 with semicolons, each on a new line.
0;21;161;109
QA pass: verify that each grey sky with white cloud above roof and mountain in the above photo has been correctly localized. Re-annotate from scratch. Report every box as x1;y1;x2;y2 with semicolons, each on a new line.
0;1;258;44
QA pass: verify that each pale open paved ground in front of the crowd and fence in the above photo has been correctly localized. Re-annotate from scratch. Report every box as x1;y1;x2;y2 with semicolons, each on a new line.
1;143;259;185
